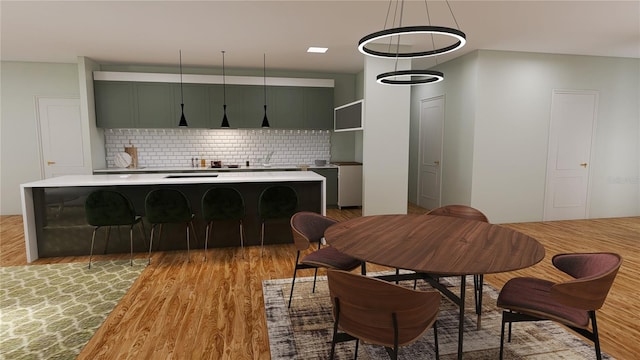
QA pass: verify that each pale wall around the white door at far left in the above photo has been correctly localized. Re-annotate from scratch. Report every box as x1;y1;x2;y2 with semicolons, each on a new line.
0;61;80;215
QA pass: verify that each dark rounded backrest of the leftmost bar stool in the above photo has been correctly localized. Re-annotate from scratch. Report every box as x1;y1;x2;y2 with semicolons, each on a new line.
84;190;136;226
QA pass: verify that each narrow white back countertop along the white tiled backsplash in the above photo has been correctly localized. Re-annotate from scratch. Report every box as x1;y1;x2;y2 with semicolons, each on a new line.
93;164;337;174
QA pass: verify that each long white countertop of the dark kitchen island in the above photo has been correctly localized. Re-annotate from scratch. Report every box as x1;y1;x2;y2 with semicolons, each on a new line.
20;171;325;188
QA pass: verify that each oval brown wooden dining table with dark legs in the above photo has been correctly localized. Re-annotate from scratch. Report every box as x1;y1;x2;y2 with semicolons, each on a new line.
324;214;545;359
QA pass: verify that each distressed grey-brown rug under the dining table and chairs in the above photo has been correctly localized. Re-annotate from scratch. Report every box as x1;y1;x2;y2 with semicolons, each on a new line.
262;277;612;360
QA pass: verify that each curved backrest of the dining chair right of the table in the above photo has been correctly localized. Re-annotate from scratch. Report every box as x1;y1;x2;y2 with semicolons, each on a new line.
551;253;622;310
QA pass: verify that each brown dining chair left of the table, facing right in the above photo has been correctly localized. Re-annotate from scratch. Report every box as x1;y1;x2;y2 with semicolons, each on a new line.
289;211;366;307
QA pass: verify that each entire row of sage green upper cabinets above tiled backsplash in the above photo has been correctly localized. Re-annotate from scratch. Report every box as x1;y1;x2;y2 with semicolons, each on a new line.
94;80;333;130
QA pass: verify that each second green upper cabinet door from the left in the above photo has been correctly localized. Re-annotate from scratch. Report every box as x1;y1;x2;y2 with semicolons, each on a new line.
134;83;175;128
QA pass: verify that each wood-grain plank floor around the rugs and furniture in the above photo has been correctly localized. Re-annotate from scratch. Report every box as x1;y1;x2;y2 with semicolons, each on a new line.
0;207;640;360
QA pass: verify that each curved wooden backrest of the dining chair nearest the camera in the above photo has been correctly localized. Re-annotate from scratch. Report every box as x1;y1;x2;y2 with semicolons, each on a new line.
327;270;441;347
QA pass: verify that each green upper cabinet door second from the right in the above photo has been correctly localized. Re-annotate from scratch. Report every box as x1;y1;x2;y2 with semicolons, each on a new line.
271;86;306;129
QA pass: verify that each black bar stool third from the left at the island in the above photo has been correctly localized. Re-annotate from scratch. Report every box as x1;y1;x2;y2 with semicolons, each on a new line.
202;187;245;261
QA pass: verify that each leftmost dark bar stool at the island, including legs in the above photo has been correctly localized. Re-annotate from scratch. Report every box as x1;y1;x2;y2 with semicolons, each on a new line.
84;190;146;269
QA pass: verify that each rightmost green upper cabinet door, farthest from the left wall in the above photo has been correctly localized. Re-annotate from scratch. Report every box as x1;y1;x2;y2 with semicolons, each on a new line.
304;88;334;129
